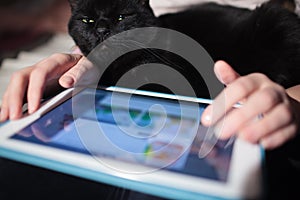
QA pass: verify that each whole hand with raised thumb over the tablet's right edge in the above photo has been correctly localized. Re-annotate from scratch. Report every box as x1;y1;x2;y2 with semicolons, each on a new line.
201;61;300;149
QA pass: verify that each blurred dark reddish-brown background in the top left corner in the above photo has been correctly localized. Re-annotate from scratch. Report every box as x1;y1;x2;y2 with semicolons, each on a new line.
0;0;70;62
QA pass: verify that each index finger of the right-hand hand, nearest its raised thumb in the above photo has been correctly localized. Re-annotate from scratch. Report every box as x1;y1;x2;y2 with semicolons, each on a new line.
201;74;268;126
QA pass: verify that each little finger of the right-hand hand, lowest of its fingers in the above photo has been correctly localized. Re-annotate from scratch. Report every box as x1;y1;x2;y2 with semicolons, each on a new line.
260;125;297;150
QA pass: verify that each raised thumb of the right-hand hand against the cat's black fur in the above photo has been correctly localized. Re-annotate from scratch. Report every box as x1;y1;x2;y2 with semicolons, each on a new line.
214;61;240;85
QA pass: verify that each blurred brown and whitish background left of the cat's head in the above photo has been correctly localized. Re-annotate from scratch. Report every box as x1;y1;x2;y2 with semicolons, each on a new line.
0;0;75;104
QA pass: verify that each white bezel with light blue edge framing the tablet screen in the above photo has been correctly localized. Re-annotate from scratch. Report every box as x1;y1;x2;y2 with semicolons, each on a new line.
0;87;264;199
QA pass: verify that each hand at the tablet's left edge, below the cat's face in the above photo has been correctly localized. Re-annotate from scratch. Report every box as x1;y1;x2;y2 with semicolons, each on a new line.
0;53;90;121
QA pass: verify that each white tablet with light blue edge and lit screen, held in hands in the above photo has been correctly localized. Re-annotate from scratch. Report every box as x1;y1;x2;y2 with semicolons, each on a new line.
0;87;264;199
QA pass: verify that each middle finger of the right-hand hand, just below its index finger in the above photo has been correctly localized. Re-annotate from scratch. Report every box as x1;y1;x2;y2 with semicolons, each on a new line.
216;87;288;139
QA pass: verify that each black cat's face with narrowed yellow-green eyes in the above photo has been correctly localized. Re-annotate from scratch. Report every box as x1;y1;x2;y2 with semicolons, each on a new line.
69;0;158;55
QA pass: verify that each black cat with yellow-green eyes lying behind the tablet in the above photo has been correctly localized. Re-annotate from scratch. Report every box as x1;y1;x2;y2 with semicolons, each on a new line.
69;0;300;97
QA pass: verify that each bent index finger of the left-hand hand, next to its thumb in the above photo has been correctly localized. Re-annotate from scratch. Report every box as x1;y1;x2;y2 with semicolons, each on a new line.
27;54;82;114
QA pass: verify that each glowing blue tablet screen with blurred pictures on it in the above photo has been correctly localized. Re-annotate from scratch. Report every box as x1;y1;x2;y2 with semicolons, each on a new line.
11;89;234;182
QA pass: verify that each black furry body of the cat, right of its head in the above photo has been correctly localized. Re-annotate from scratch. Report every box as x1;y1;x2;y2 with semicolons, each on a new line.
161;2;300;87
